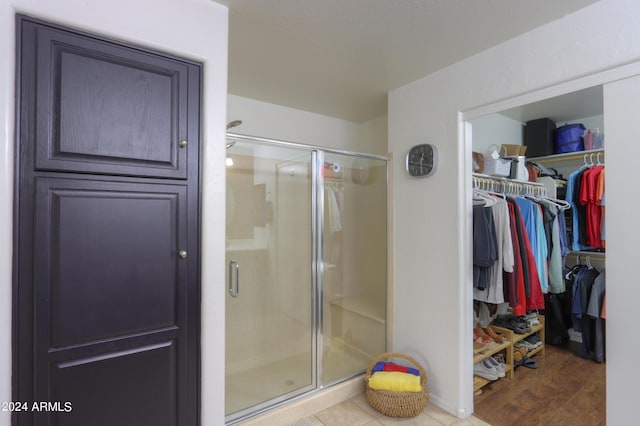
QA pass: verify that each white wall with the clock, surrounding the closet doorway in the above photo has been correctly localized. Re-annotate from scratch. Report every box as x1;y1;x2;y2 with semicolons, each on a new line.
389;0;640;424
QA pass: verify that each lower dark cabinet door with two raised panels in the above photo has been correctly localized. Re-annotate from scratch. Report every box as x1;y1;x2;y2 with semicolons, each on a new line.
34;178;189;425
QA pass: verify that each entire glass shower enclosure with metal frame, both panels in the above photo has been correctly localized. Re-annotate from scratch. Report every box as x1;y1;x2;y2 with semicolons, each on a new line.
225;135;387;423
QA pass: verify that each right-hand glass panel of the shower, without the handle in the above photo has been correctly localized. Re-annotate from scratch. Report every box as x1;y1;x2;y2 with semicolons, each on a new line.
318;151;387;385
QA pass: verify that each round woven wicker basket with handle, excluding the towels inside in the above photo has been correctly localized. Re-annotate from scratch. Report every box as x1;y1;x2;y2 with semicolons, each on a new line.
364;352;429;417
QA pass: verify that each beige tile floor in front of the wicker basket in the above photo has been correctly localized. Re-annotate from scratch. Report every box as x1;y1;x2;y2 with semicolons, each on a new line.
288;394;489;426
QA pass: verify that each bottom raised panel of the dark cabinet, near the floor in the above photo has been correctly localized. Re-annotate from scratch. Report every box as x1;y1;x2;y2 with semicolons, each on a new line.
49;341;181;426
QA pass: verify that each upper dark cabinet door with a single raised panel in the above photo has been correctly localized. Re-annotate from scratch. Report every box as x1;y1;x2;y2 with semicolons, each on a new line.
23;19;194;179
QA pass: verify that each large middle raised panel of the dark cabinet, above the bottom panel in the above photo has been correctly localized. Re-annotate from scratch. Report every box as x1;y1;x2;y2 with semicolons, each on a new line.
35;178;187;349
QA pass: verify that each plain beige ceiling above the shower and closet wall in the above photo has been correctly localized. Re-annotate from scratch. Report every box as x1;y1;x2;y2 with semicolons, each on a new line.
215;0;596;122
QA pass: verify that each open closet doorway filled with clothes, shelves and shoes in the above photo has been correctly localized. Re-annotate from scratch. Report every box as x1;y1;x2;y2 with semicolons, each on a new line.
465;86;609;424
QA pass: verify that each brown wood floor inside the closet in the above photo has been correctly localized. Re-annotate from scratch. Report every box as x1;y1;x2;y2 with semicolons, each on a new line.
474;345;606;426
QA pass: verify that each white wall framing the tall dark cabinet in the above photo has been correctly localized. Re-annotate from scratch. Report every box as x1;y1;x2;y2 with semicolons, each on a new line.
0;0;228;426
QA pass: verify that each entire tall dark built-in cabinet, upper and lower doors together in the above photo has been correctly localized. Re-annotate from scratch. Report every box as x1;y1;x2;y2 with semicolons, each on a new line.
14;16;201;426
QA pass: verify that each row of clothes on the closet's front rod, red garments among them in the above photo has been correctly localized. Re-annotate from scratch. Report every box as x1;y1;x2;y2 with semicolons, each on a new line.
473;175;569;316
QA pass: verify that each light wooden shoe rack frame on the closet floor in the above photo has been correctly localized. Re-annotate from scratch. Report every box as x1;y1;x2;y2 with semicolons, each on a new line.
473;314;545;393
